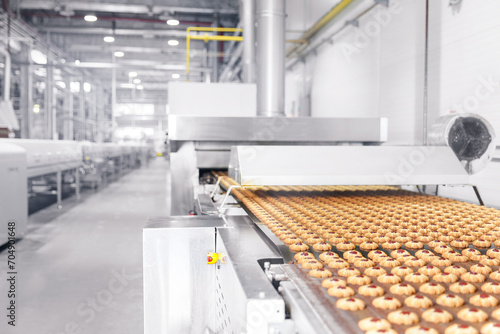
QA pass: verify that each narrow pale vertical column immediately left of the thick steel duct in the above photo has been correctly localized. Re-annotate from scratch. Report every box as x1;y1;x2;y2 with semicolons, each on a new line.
240;0;256;83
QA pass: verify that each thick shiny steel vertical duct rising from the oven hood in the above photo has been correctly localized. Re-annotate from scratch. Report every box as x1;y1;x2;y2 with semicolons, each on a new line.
256;0;285;117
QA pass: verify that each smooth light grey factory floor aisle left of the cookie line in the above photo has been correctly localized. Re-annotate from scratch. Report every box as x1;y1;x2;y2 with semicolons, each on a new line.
0;159;170;334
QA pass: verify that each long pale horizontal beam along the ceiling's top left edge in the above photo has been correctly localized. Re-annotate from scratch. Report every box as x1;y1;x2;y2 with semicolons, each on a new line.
12;0;238;15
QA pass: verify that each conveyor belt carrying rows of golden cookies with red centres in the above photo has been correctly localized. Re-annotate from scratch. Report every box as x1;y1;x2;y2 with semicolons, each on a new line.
216;177;500;333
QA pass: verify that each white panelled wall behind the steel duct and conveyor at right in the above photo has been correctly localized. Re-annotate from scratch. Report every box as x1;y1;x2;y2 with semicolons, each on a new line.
285;0;500;206
